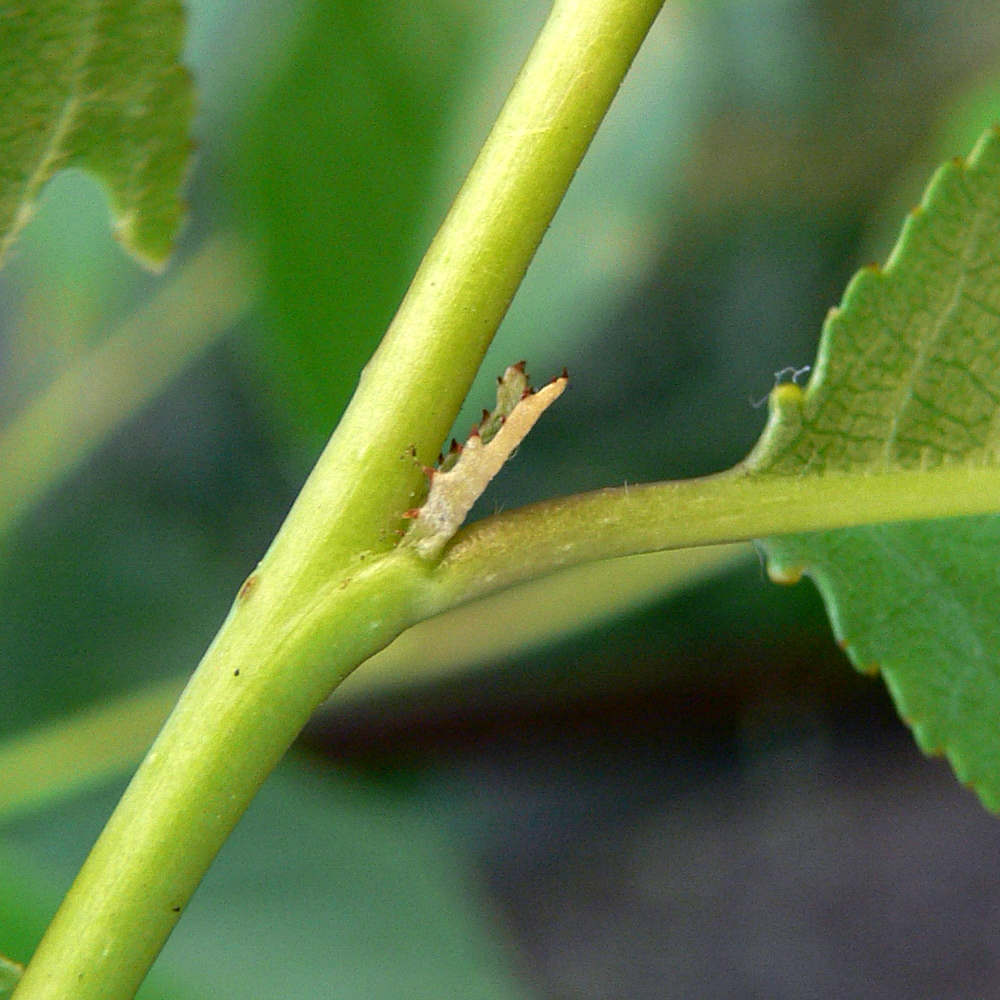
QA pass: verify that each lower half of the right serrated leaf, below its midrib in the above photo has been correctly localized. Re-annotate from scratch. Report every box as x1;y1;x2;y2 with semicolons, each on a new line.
766;517;1000;800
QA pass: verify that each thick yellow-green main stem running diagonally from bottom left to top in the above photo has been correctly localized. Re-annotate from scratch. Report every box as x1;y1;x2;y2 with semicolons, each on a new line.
15;0;662;1000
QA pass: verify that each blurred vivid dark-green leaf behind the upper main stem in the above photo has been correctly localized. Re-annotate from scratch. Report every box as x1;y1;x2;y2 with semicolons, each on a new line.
233;0;478;444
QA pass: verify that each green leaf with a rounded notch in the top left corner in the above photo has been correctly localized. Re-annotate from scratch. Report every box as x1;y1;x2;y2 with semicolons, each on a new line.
0;0;193;267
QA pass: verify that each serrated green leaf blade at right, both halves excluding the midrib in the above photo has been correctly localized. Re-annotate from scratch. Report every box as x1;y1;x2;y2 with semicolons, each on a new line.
747;129;1000;810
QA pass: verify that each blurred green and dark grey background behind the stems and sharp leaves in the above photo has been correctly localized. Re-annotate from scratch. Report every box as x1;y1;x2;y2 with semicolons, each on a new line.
0;0;1000;1000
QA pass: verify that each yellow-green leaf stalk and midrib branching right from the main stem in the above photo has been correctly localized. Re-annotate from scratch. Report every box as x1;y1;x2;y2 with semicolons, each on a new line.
421;466;1000;614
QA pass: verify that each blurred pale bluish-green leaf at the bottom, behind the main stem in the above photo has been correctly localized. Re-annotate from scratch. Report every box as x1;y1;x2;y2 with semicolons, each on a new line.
0;757;527;1000
